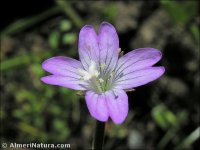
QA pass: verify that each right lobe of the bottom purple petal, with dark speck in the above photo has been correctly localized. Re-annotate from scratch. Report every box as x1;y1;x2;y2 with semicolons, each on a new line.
105;89;128;124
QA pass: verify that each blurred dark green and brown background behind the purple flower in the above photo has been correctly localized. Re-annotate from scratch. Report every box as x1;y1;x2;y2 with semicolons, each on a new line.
0;0;200;149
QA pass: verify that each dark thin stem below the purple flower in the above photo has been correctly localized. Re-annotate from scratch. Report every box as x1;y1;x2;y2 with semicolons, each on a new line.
92;120;105;150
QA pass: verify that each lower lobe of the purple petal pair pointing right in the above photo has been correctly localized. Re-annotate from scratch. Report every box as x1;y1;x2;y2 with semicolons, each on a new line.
116;67;165;89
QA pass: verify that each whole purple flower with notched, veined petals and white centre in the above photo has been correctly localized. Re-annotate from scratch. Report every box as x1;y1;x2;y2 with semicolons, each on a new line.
41;22;165;124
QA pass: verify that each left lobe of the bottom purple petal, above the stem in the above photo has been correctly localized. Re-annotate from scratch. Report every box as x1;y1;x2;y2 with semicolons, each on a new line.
85;91;108;122
